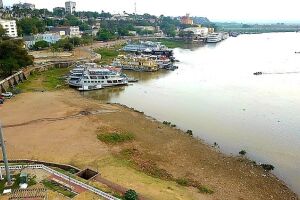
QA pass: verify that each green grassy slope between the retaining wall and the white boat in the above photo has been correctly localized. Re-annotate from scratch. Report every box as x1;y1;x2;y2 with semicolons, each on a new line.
17;68;70;92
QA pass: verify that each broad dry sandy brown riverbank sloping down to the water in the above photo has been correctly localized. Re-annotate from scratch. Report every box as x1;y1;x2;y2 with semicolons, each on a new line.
0;90;298;200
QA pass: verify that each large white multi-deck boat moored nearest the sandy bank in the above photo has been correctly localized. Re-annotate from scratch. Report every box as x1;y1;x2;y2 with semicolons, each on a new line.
68;65;128;87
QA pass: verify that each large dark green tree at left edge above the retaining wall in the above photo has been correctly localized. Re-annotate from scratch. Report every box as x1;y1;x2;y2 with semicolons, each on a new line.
0;39;33;76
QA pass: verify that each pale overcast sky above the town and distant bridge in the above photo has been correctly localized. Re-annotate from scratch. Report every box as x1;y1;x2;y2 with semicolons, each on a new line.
3;0;300;22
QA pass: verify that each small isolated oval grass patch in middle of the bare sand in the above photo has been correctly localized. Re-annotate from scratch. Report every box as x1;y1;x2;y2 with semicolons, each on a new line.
97;133;135;144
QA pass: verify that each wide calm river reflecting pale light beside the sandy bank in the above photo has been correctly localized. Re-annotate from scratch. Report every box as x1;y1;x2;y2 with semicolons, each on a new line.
85;33;300;194
